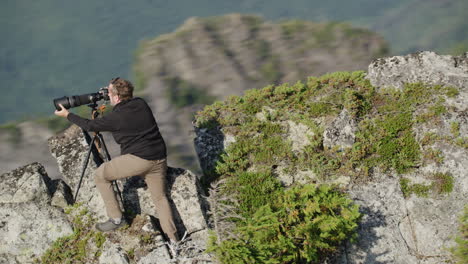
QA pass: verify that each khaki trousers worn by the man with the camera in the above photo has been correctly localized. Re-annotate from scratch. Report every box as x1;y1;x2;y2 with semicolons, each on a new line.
94;154;178;241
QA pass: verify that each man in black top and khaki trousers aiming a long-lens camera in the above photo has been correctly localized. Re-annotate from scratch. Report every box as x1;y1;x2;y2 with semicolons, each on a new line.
55;78;179;242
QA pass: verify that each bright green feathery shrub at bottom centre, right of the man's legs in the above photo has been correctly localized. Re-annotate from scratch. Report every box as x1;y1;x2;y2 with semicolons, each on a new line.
209;185;360;264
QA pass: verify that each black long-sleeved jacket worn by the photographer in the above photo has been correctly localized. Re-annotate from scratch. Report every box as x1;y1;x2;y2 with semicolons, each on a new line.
67;97;166;160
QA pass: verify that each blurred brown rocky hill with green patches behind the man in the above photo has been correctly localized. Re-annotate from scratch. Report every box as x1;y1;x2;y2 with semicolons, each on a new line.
135;14;388;169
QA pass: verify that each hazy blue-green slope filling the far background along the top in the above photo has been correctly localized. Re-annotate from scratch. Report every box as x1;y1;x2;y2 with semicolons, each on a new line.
0;0;468;123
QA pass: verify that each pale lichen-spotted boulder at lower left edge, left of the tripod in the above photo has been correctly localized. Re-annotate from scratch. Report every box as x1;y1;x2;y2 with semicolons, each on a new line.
0;163;73;263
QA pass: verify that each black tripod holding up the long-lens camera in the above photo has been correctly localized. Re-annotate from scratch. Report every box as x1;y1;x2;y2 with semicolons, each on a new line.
73;102;123;205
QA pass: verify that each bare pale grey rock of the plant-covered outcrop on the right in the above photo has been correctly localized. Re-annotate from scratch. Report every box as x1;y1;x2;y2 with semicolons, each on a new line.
194;52;468;264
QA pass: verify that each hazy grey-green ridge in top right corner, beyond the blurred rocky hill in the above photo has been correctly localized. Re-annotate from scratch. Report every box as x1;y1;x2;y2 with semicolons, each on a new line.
366;0;468;55
